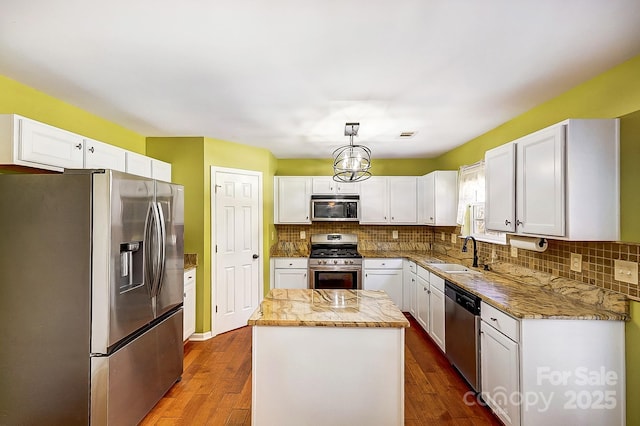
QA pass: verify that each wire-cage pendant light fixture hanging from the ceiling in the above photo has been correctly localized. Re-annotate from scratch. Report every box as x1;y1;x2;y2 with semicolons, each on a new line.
333;123;371;182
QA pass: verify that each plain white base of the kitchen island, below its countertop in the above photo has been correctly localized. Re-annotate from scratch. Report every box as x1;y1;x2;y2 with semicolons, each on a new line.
251;326;404;426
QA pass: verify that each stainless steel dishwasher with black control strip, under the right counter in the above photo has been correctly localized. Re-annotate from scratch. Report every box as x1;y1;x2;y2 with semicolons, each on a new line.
444;281;481;392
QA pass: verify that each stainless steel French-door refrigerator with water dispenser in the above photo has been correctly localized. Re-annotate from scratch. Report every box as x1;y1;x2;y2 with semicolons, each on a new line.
0;170;184;426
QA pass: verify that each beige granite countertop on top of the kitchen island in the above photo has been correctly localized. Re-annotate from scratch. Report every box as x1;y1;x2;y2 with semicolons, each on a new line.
248;288;409;328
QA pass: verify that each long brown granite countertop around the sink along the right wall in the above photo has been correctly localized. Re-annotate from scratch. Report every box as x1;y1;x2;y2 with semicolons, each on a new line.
272;250;630;321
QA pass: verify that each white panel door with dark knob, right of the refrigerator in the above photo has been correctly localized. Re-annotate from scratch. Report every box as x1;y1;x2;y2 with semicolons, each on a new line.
212;170;262;334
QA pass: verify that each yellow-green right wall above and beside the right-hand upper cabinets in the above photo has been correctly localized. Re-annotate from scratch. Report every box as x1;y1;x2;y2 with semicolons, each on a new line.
428;56;640;425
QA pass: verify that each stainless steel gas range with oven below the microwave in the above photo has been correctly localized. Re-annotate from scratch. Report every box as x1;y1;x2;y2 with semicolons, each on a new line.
309;234;362;290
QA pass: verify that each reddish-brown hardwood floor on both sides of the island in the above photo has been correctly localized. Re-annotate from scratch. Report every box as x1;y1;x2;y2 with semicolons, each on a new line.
141;316;501;426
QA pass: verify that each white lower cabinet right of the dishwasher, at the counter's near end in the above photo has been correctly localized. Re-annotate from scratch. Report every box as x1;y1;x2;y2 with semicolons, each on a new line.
480;302;626;426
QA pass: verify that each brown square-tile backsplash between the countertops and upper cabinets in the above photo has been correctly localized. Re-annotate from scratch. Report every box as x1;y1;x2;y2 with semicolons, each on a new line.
276;222;640;300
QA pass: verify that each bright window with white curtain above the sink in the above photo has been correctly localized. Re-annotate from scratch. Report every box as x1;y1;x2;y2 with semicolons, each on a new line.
458;161;507;244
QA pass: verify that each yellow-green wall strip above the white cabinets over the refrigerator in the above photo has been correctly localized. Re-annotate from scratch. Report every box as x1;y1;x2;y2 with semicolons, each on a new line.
0;75;145;154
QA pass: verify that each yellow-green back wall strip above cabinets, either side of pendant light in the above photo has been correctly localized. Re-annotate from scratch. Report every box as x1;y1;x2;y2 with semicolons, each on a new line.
276;157;436;176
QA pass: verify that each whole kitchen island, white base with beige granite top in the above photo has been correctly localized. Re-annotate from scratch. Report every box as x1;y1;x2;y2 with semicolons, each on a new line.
248;289;409;425
